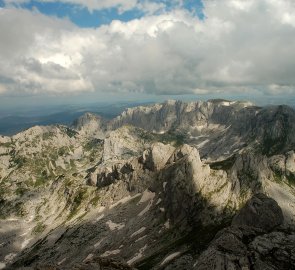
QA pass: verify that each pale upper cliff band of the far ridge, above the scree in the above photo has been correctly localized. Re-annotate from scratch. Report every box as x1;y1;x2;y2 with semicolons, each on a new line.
109;100;252;132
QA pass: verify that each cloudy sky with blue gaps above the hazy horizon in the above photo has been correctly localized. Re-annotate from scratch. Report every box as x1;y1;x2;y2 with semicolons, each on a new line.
0;0;295;109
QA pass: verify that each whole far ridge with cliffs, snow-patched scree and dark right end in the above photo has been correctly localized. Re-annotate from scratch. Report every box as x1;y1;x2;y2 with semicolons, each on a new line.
108;100;295;159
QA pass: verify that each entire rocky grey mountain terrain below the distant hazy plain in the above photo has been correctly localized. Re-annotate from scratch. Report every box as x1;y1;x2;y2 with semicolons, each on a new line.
0;100;295;270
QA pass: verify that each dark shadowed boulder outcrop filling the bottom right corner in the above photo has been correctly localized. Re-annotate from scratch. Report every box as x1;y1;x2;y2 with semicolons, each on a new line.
194;194;295;270
